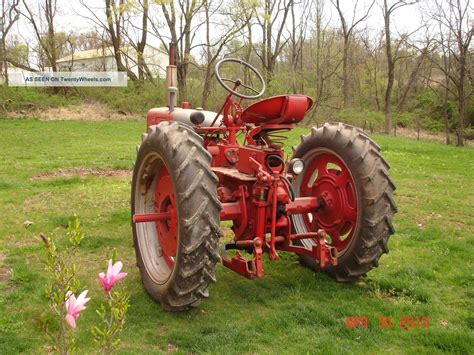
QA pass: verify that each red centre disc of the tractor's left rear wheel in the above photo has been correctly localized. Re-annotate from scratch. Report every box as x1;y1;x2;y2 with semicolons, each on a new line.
155;164;178;269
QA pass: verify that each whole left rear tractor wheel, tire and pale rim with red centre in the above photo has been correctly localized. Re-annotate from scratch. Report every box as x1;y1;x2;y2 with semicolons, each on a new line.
131;122;222;311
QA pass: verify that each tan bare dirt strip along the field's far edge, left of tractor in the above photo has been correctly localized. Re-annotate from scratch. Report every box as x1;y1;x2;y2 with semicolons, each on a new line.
7;103;143;121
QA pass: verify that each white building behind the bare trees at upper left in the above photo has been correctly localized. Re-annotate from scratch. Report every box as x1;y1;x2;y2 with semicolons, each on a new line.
56;45;169;78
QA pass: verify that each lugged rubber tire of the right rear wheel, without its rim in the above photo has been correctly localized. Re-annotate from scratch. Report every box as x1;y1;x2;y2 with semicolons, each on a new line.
294;123;397;282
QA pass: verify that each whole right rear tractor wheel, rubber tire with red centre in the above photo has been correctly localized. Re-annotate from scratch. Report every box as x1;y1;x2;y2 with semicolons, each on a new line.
292;123;397;282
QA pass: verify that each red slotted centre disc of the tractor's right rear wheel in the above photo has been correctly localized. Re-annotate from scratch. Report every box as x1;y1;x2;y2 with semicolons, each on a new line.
300;151;357;252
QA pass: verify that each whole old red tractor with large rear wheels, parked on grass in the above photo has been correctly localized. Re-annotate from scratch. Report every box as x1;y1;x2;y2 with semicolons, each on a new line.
131;51;396;311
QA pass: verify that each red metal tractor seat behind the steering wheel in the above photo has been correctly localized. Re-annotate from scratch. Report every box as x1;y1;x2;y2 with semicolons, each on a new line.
240;95;313;125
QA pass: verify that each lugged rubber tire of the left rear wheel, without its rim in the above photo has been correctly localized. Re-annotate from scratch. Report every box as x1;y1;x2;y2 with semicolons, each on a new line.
132;122;222;311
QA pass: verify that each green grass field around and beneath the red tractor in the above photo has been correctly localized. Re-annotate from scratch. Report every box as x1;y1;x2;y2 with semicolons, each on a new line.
0;120;474;354
